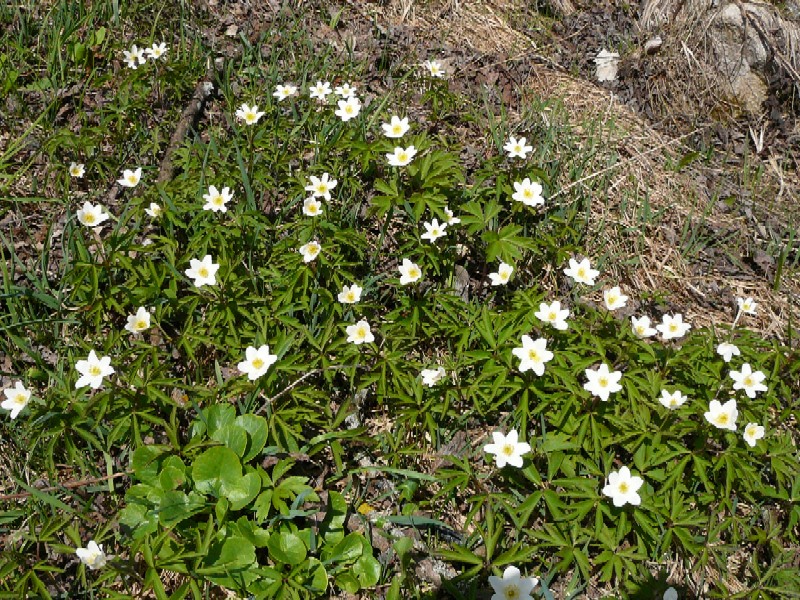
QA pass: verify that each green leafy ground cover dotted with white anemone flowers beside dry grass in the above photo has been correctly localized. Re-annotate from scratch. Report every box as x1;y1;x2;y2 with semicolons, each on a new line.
0;1;800;599
